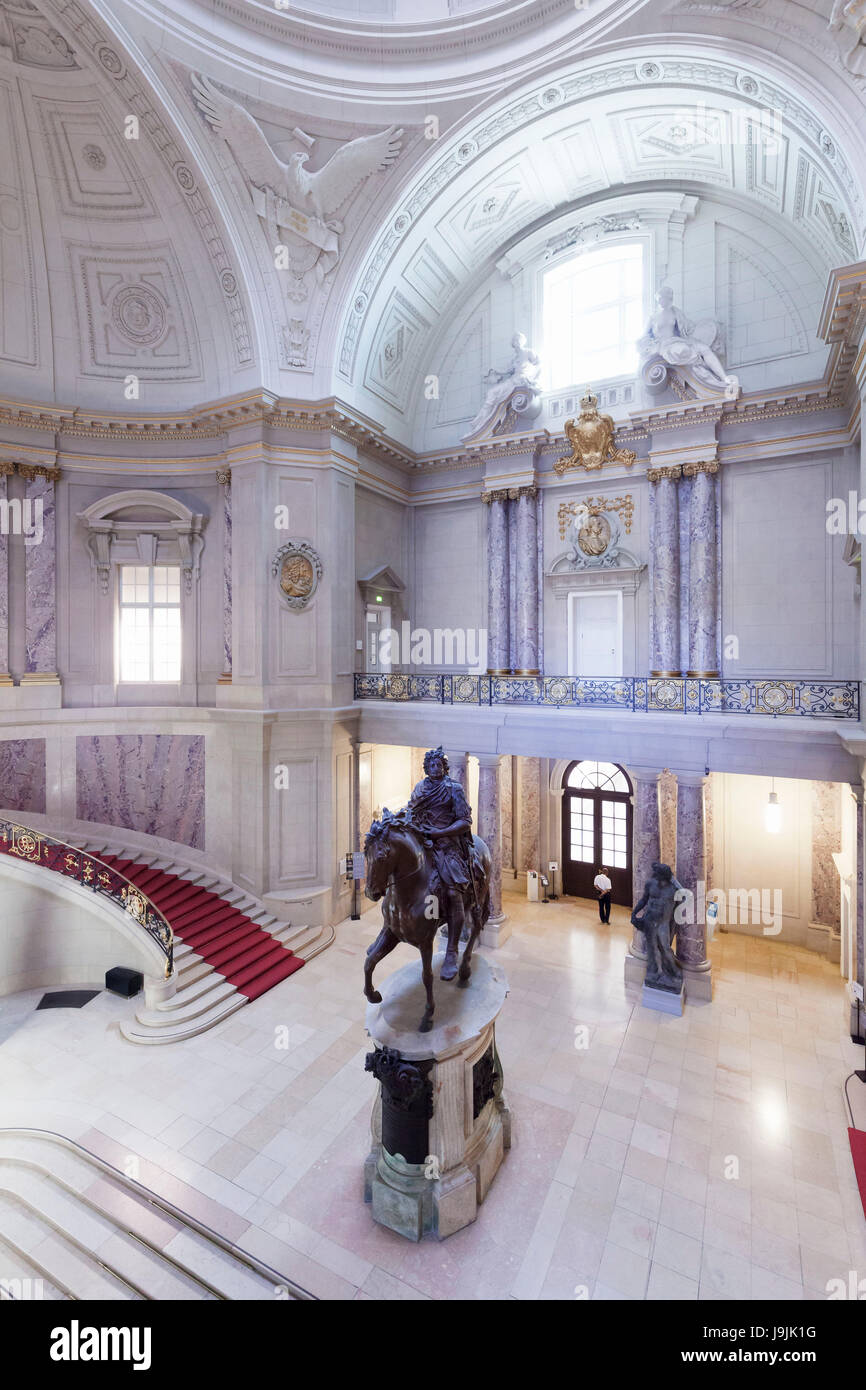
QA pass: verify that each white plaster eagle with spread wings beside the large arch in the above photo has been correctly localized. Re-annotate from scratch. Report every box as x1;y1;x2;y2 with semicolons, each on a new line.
192;74;403;284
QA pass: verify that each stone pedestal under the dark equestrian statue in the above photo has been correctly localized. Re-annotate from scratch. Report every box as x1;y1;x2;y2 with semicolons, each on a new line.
364;952;512;1240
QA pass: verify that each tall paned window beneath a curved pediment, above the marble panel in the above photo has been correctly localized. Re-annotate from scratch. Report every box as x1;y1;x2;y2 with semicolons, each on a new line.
120;564;181;684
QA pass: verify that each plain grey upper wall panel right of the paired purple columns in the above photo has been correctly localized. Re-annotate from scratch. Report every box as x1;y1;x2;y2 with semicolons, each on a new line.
721;457;855;678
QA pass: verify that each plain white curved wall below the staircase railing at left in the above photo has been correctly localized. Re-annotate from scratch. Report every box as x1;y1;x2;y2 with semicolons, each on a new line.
0;863;156;995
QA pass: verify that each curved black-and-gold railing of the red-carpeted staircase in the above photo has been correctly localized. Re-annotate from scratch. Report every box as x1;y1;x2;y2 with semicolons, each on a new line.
0;820;174;979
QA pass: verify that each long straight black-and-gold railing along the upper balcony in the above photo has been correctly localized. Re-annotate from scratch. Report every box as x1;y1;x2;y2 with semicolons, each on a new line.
354;671;860;720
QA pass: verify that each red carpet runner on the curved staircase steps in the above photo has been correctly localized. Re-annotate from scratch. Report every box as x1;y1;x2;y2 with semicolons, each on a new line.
99;855;304;999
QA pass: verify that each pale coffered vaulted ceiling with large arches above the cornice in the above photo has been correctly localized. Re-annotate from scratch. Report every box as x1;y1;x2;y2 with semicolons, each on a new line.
0;0;866;428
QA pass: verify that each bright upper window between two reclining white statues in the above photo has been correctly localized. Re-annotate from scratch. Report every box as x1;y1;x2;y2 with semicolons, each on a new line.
542;242;644;391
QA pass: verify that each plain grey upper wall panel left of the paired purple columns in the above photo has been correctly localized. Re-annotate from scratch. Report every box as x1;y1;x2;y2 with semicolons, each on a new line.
414;500;487;669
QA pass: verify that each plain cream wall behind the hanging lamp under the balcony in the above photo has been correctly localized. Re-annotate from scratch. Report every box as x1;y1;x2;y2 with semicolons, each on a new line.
713;773;812;945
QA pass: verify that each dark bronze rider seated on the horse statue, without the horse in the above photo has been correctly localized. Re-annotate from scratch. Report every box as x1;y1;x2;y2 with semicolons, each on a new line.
407;746;480;980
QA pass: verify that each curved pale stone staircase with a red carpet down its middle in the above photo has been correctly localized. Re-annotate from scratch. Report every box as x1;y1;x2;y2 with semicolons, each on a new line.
63;842;332;1044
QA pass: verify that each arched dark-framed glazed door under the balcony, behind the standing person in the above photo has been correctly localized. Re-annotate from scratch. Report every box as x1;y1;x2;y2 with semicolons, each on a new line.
563;760;631;904
